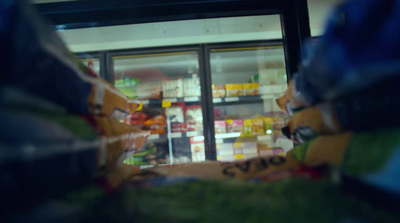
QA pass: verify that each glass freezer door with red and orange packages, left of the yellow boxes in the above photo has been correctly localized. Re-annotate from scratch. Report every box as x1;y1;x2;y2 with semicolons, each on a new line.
113;52;205;167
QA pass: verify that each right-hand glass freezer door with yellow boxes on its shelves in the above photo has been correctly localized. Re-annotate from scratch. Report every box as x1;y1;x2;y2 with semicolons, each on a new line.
210;47;289;161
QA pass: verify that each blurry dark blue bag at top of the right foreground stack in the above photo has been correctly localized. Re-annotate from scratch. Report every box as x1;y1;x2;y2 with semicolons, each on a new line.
295;0;400;104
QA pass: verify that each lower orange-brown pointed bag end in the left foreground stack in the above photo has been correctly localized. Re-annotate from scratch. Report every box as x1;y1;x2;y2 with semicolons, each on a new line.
93;116;150;171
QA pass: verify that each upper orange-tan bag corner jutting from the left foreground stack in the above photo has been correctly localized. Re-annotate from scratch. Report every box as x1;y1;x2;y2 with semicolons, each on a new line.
88;78;140;120
